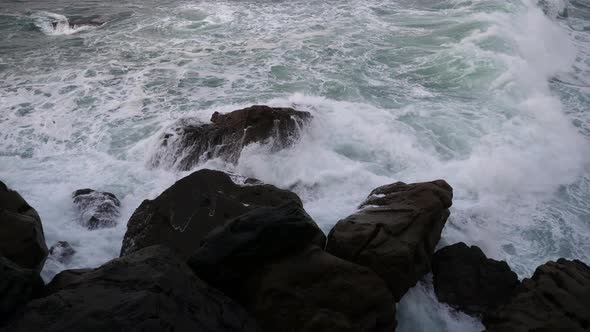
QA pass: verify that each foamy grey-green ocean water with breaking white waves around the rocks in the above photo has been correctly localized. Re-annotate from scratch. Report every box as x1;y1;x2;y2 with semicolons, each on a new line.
0;0;590;331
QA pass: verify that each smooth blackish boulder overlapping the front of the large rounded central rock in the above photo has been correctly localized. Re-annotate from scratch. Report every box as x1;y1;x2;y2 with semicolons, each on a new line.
189;202;326;298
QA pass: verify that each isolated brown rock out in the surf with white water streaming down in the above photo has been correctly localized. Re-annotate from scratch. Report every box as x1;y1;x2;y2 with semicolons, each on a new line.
152;105;311;170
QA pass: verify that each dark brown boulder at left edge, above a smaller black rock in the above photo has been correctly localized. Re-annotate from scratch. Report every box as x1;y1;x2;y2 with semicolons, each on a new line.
0;182;47;272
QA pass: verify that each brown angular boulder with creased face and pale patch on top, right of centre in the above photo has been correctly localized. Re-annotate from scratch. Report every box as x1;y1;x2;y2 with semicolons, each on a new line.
326;180;453;301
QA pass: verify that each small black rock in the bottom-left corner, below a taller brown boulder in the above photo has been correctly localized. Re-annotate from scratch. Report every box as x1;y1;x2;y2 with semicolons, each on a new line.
0;256;43;326
